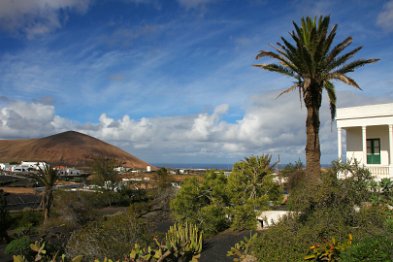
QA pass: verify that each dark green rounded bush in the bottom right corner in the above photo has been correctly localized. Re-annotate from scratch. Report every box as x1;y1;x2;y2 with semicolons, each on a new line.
340;235;393;262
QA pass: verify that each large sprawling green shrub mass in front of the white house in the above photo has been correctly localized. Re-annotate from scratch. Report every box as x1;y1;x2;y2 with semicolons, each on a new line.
242;163;393;261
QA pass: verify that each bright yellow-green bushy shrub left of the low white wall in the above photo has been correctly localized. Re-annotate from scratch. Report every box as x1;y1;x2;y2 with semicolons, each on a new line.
171;155;282;235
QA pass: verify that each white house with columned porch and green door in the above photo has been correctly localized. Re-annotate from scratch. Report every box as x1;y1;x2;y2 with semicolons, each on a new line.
336;103;393;180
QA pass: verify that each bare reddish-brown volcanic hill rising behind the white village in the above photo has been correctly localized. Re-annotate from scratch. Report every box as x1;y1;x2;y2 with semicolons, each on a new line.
0;131;151;169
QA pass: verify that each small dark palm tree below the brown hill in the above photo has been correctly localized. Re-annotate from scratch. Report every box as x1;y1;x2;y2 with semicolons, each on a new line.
36;165;58;224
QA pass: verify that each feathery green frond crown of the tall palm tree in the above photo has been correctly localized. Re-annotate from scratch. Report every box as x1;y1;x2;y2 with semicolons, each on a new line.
255;16;379;123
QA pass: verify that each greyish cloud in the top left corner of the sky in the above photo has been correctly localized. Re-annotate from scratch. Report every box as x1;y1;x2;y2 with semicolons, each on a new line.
0;0;90;38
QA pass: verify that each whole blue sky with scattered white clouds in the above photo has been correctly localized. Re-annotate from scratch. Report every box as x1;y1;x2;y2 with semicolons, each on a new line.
0;0;393;164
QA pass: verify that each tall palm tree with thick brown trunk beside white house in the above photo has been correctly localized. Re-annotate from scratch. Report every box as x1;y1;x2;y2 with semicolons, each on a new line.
254;16;379;177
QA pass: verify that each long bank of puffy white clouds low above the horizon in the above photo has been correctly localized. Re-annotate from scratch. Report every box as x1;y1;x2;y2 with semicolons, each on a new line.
0;92;381;163
